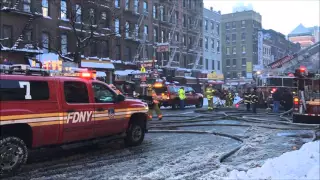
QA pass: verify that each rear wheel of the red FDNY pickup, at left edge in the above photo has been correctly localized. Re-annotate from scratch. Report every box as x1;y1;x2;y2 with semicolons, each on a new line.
0;136;28;177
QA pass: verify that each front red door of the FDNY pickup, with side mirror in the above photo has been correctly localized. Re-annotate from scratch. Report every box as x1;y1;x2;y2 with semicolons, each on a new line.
92;82;127;137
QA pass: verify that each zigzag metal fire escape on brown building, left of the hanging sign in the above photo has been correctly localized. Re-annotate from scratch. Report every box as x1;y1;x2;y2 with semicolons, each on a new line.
133;10;147;62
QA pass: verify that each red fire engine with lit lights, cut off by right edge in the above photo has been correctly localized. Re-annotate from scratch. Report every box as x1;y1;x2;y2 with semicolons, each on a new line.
293;67;320;124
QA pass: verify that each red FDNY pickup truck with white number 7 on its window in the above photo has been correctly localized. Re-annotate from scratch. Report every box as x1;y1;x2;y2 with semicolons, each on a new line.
0;65;148;177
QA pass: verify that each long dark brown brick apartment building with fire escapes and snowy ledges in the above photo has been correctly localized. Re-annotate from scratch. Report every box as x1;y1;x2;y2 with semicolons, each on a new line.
0;0;203;70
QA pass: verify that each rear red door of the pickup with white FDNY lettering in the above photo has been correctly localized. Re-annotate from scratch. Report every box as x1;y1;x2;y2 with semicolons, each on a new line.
62;79;94;142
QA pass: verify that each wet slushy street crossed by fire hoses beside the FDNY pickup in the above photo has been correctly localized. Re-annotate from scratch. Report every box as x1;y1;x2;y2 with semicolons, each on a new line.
10;108;318;180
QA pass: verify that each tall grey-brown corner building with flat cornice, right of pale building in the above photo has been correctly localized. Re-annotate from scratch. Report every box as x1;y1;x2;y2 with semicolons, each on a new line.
221;10;261;80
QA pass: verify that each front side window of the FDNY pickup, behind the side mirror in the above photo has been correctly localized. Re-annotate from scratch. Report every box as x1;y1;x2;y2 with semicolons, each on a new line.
92;83;115;103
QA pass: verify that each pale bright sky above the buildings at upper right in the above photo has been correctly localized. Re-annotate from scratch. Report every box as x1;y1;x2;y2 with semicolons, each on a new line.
203;0;320;35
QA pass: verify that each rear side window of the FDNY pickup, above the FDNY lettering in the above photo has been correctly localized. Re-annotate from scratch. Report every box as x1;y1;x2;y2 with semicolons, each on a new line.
64;81;89;103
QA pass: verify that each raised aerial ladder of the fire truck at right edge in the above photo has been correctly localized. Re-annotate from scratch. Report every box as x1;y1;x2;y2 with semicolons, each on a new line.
266;42;320;73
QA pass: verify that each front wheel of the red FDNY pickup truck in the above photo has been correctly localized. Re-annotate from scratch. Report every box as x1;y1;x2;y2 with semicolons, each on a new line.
124;121;145;147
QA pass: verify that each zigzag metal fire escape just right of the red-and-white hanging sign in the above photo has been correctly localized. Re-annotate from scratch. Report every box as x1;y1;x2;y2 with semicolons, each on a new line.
166;0;181;67
